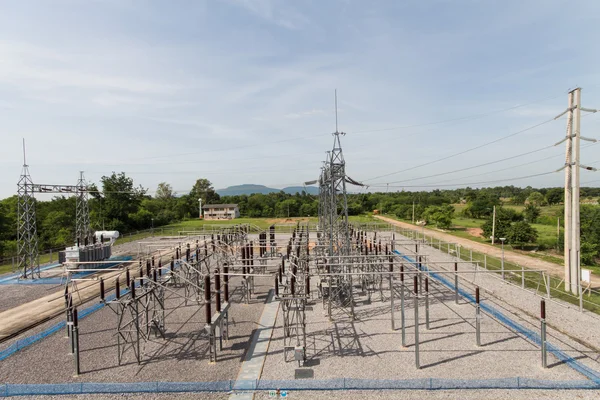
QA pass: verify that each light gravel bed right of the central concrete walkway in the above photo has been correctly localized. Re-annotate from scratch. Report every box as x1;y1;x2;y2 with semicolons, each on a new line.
262;228;600;393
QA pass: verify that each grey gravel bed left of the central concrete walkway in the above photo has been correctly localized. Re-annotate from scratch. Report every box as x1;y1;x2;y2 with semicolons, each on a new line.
0;270;268;383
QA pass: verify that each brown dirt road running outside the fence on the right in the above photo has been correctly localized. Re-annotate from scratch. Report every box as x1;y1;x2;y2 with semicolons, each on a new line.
374;215;600;287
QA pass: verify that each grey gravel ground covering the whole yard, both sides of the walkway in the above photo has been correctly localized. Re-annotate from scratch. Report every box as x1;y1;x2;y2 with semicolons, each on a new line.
0;233;600;400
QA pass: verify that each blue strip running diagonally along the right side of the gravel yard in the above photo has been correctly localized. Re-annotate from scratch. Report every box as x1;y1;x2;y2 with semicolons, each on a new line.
394;250;600;384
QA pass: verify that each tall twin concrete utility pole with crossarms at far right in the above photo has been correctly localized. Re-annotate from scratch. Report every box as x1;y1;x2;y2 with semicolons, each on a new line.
554;88;597;294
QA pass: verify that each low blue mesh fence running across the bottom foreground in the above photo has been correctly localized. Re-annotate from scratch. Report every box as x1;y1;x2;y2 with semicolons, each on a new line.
0;377;600;397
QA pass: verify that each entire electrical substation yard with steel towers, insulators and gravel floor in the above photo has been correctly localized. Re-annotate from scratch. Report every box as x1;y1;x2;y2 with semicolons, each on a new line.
0;132;600;398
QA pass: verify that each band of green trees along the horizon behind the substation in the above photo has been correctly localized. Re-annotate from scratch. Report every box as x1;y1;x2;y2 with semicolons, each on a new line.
0;172;600;261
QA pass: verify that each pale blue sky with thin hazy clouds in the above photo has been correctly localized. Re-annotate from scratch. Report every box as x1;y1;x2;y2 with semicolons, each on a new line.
0;0;600;198
